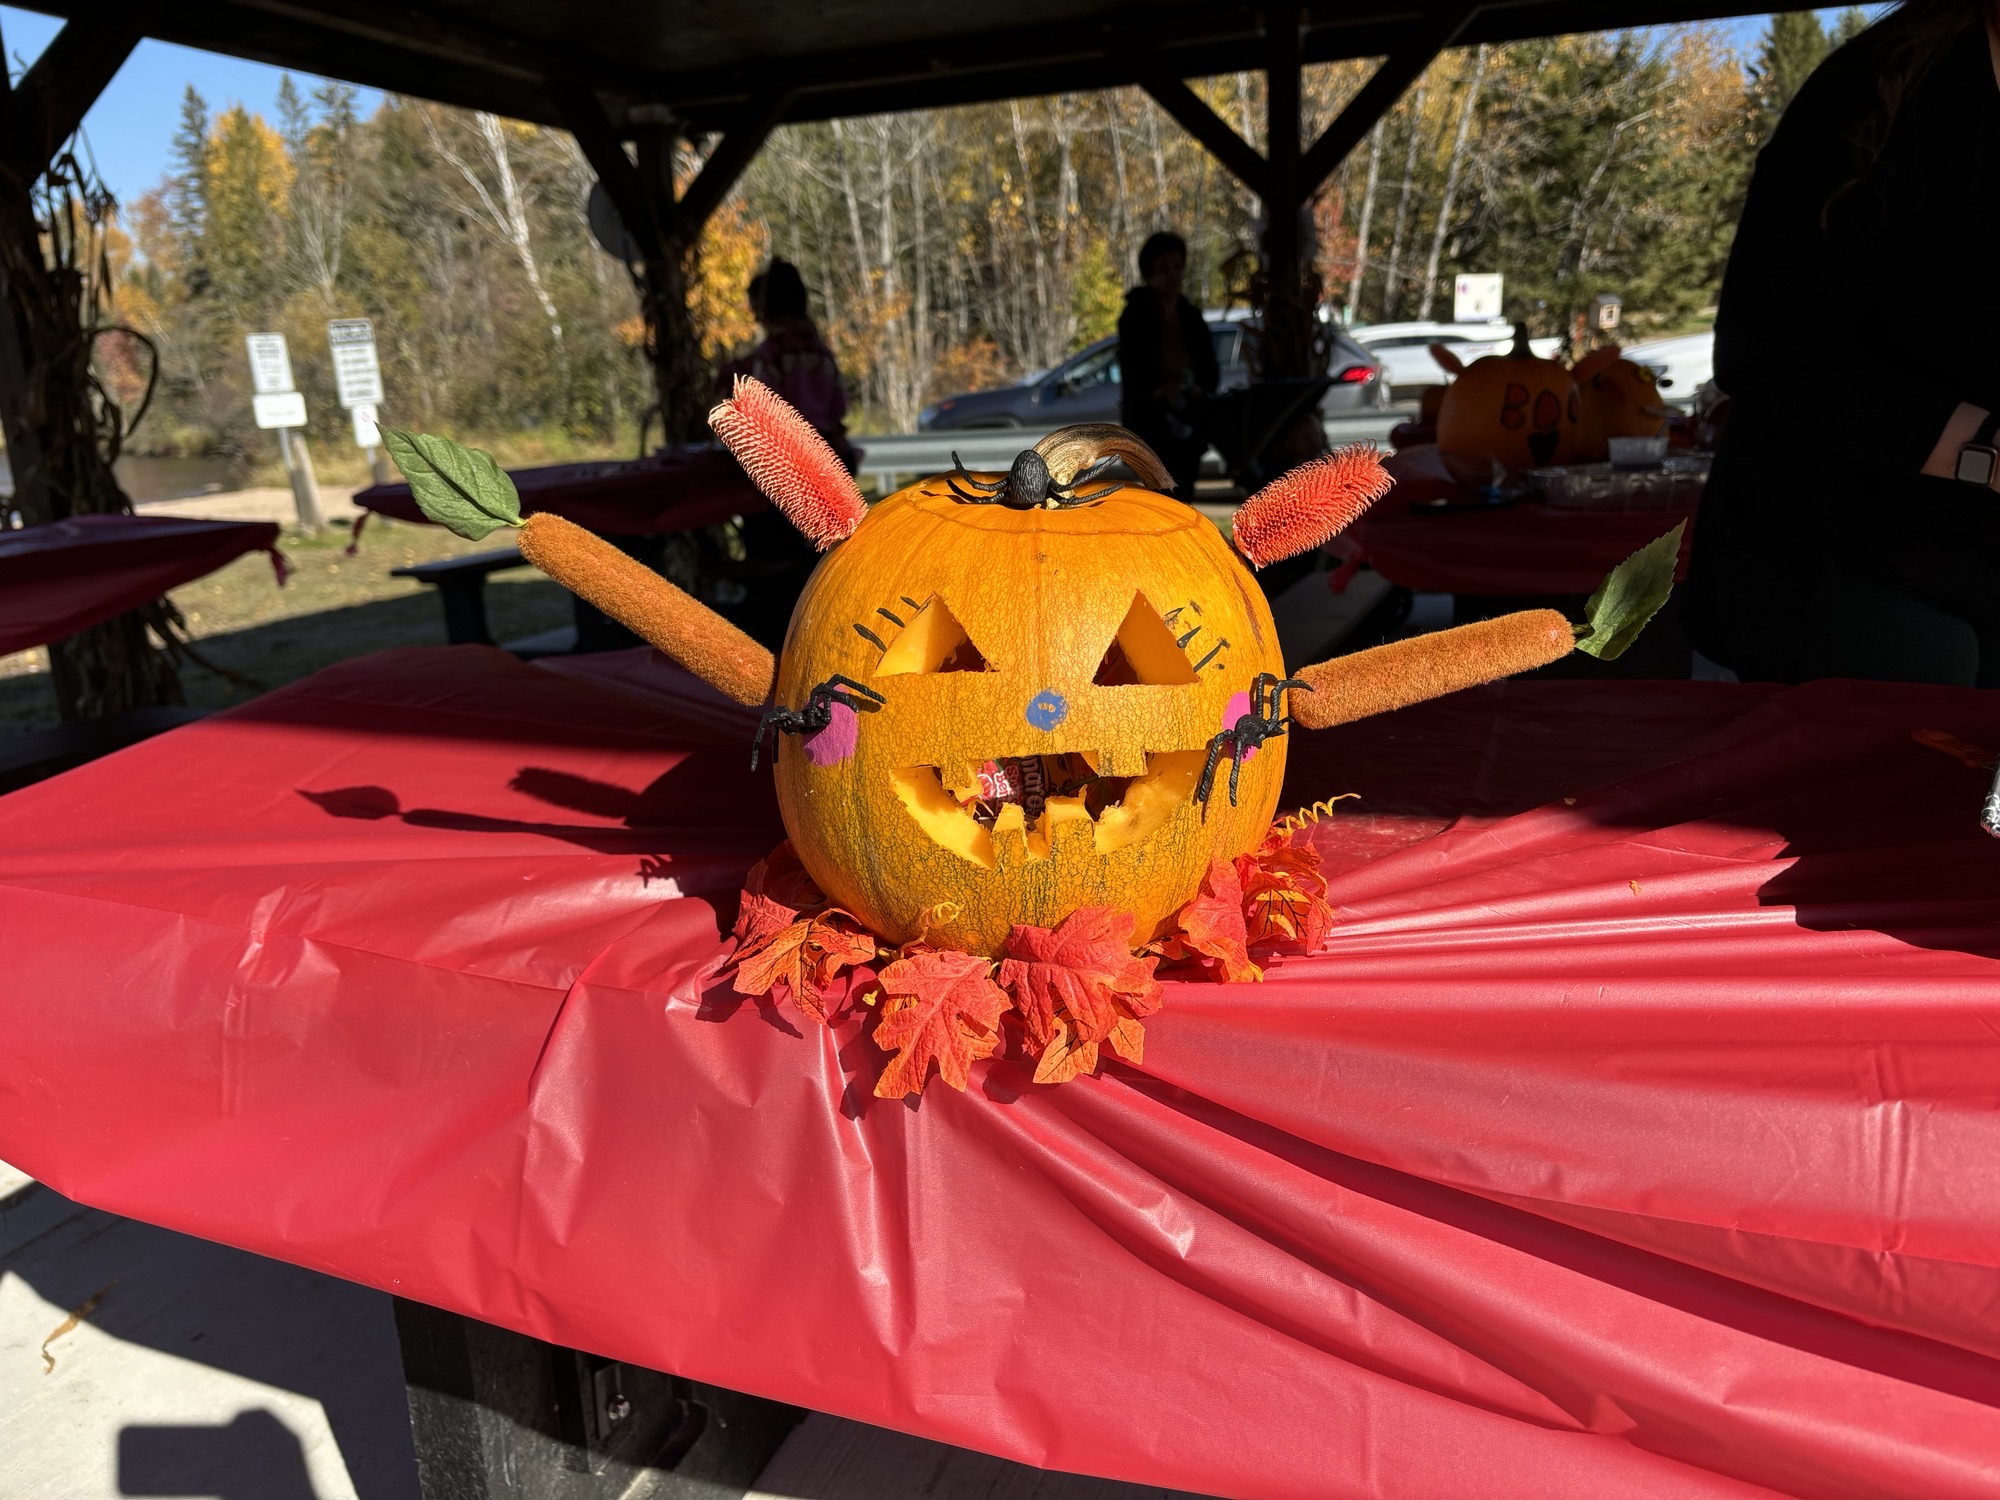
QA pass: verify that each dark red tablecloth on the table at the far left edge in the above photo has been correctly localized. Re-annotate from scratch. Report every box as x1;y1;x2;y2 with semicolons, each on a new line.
0;516;282;656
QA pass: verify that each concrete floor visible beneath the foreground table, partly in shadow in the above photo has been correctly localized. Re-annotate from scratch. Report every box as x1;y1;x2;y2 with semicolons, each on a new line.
0;1162;1192;1500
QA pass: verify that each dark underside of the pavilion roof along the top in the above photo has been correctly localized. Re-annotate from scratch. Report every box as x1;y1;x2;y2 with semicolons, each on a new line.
32;0;1768;128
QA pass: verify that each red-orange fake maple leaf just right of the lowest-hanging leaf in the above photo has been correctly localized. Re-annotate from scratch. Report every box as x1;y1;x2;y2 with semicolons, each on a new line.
1000;906;1162;1052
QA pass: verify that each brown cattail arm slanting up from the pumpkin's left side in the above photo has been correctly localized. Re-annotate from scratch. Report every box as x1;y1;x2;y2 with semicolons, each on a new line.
518;512;778;708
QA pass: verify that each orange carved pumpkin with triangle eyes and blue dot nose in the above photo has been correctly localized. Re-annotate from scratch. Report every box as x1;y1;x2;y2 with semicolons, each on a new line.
776;478;1286;956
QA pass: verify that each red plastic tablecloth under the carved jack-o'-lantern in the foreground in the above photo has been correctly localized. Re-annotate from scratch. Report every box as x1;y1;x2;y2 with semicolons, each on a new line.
0;648;2000;1500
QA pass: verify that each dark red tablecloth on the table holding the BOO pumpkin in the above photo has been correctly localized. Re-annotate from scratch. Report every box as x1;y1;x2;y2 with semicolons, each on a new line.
1344;444;1694;598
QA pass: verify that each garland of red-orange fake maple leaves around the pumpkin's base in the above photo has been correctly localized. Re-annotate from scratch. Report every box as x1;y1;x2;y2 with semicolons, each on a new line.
730;820;1334;1098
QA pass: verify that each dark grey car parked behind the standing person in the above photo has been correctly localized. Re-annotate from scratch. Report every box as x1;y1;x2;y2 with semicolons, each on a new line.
916;314;1388;432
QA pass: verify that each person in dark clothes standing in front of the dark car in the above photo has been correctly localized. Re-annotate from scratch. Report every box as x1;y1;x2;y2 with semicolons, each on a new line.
1118;232;1222;500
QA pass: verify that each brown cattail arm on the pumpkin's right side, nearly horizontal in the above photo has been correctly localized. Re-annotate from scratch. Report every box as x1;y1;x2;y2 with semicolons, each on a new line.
1286;610;1576;730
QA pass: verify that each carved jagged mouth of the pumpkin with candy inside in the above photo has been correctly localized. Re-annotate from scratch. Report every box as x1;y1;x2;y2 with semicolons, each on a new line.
890;750;1206;868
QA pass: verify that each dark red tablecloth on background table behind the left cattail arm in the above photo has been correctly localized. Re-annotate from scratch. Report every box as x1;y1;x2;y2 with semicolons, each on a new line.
354;448;770;536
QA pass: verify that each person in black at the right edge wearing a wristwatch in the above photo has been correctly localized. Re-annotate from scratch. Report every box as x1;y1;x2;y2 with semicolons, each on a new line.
1688;0;2000;686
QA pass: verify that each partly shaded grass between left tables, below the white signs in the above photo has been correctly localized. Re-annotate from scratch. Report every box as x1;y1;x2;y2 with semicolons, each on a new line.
0;516;572;734
